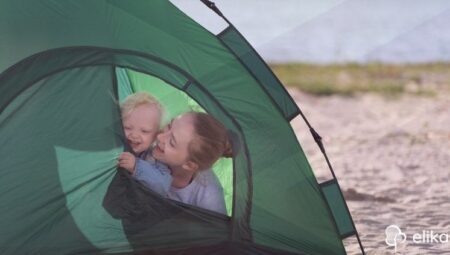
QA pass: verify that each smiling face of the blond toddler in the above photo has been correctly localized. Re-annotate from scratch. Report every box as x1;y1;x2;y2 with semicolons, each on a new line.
122;105;161;154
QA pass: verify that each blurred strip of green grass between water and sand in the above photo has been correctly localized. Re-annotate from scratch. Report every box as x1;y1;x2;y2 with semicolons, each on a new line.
270;63;450;97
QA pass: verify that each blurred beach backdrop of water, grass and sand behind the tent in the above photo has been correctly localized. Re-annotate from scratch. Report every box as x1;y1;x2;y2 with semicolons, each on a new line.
172;0;450;254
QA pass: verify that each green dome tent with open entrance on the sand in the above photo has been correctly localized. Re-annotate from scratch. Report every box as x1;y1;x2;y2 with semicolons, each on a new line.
0;0;359;255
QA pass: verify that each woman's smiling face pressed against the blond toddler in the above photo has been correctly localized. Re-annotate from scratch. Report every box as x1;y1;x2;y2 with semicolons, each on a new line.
152;114;194;170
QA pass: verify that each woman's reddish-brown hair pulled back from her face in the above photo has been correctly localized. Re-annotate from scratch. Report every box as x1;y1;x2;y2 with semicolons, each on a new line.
188;112;232;170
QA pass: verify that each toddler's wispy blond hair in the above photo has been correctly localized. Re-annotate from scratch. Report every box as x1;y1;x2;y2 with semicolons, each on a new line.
120;92;163;118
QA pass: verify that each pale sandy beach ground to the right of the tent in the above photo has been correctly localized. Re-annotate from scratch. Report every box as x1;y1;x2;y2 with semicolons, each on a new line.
289;90;450;254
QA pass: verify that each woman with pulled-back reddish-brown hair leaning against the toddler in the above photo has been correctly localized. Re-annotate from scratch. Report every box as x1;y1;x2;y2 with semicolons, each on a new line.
152;112;231;214
